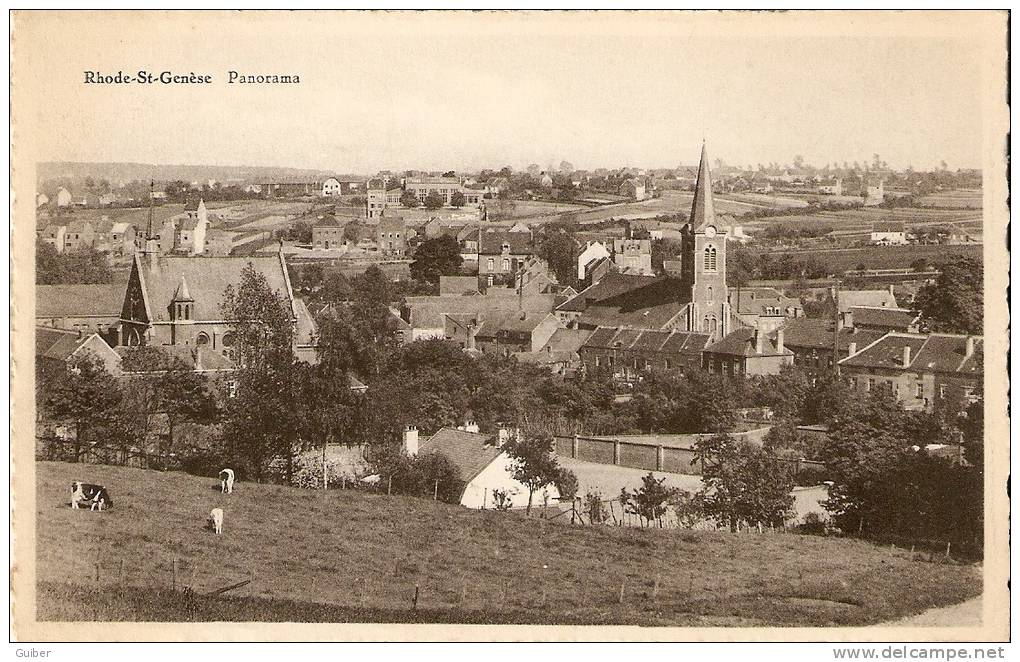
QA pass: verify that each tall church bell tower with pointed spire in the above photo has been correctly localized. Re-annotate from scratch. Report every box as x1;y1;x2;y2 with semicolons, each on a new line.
680;143;729;342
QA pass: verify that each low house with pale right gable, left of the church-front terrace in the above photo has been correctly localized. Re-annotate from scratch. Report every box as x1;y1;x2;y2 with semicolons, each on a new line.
445;310;560;357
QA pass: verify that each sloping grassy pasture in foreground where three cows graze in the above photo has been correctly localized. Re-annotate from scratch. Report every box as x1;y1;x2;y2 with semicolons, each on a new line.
37;462;980;625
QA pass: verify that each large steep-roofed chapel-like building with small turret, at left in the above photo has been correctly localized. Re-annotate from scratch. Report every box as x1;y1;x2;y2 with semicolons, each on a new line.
117;250;314;358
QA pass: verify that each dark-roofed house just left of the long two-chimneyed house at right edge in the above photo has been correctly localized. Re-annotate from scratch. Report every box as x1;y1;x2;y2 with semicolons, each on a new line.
783;317;884;377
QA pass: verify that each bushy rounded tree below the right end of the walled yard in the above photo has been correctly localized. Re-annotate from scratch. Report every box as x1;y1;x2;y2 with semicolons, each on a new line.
695;435;794;530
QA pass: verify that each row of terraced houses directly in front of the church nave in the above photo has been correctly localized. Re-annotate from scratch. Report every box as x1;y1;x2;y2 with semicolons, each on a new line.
577;326;709;381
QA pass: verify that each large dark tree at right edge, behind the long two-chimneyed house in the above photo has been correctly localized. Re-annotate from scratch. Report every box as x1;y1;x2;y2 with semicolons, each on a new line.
915;256;984;335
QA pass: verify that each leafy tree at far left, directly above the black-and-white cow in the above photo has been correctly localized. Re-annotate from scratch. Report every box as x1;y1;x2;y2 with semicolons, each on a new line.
40;355;122;462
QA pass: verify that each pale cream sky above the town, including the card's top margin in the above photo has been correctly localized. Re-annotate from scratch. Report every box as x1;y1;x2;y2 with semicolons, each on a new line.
13;12;989;173
